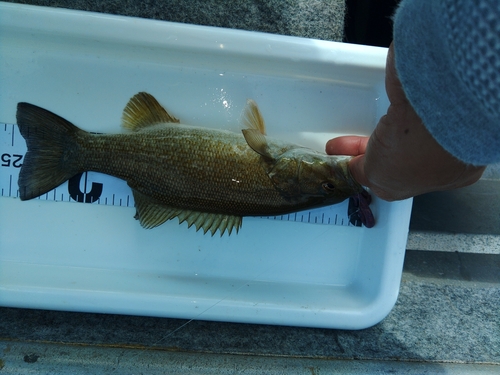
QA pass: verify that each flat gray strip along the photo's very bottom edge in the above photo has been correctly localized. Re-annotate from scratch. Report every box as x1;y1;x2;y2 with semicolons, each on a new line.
0;342;498;375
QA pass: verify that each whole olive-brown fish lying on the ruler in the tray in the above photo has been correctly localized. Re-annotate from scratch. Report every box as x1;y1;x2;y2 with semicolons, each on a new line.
17;92;370;236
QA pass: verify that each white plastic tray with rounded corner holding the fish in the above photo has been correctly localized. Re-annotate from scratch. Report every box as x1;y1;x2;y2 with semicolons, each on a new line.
0;3;411;329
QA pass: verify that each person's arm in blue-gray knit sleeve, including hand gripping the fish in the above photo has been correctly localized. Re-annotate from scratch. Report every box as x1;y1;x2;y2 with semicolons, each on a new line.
326;0;500;200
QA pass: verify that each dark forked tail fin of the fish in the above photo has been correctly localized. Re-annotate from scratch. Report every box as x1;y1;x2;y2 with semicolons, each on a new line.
17;103;88;200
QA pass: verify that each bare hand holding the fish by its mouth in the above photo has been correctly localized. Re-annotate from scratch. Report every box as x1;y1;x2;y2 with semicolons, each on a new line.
326;44;485;201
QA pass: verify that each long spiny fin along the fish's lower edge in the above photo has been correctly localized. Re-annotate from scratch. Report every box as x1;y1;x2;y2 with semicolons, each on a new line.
132;189;242;237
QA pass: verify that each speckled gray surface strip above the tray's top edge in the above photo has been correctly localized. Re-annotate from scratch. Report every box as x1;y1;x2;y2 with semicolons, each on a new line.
3;0;345;41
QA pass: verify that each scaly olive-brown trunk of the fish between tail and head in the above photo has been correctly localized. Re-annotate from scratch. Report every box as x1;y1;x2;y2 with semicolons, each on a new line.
79;124;290;215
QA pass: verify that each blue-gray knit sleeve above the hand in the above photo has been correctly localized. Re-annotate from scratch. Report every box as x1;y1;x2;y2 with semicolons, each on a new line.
394;0;500;165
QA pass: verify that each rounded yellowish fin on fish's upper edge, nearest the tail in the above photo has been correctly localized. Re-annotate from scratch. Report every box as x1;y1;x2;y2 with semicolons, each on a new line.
122;92;179;131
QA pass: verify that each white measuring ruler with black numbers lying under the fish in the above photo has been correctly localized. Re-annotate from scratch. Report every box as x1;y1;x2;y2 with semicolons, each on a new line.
0;123;361;226
